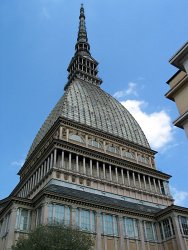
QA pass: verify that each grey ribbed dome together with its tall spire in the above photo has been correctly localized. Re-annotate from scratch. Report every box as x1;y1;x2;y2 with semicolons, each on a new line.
28;6;150;156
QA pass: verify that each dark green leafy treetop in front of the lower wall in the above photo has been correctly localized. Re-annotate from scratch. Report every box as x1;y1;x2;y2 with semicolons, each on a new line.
12;225;94;250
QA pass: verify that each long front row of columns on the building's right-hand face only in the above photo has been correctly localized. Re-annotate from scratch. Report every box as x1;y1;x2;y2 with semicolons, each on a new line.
56;148;170;196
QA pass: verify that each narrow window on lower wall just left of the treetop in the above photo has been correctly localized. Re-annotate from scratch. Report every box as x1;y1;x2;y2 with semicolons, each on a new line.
16;208;31;231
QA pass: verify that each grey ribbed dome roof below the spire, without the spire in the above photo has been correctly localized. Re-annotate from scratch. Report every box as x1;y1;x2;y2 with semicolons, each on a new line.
28;79;150;156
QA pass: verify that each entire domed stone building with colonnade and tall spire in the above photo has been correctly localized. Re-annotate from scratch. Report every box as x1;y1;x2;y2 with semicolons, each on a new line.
0;6;188;250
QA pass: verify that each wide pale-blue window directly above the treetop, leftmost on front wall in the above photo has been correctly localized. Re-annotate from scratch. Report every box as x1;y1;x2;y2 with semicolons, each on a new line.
48;204;70;225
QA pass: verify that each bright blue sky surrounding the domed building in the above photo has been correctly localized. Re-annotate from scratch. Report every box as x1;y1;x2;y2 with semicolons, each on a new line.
0;0;188;206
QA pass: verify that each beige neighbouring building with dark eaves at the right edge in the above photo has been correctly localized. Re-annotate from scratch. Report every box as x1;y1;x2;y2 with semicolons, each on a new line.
165;42;188;136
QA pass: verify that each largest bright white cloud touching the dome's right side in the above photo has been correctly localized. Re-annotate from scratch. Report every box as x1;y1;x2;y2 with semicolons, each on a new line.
121;100;173;150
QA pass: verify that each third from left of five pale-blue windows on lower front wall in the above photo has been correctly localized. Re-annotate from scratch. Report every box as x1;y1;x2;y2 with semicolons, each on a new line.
101;214;118;235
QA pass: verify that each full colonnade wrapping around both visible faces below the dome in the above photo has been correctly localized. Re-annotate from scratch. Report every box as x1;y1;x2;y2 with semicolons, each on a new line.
19;149;170;201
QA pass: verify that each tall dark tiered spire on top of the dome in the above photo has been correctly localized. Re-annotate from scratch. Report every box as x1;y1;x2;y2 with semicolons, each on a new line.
65;4;102;90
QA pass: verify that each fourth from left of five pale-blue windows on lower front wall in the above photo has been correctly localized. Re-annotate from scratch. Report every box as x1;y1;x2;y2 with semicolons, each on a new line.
123;218;138;238
